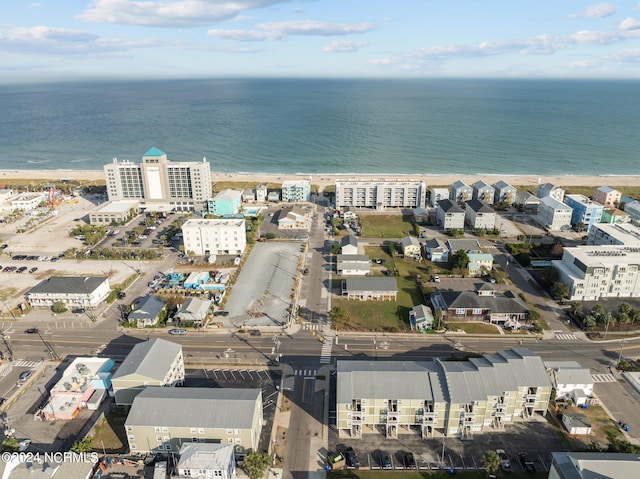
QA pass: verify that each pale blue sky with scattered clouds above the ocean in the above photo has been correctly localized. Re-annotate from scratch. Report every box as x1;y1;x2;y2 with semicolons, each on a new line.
0;0;640;82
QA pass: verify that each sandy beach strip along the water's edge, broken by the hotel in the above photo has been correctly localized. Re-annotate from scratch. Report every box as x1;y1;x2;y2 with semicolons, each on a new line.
0;170;640;189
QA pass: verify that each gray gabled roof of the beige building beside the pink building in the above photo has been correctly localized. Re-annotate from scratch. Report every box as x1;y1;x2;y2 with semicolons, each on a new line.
113;338;182;381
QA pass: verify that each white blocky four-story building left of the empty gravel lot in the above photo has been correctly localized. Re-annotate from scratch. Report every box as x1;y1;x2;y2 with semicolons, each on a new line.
182;218;247;256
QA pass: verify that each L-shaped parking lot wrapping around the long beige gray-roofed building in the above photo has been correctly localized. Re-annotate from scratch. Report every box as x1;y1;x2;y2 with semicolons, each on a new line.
184;368;280;451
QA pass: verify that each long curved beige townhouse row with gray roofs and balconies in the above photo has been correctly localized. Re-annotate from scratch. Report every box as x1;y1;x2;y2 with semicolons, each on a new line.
336;348;551;438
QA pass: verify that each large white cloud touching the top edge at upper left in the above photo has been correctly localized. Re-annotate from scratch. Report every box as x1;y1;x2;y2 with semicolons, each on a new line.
77;0;288;27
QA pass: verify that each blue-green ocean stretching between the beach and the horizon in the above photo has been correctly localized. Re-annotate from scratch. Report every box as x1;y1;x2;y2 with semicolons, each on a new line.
0;79;640;175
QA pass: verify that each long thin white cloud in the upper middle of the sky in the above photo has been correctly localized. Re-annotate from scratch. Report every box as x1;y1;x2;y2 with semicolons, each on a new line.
207;20;375;41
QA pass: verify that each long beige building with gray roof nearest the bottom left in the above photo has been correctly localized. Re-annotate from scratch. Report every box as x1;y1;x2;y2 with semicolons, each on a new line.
125;388;263;453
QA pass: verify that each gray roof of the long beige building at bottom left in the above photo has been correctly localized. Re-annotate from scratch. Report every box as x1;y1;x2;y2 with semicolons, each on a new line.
125;387;262;429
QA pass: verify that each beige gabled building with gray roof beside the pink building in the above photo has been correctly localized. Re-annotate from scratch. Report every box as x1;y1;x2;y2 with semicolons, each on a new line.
111;339;184;405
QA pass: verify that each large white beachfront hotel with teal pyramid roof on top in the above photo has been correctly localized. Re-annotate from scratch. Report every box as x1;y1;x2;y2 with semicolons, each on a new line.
104;148;211;211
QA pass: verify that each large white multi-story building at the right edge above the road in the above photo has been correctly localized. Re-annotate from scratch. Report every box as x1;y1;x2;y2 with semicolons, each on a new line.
553;246;640;301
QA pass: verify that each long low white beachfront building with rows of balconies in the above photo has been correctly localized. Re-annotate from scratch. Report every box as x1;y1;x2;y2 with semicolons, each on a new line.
336;179;427;209
